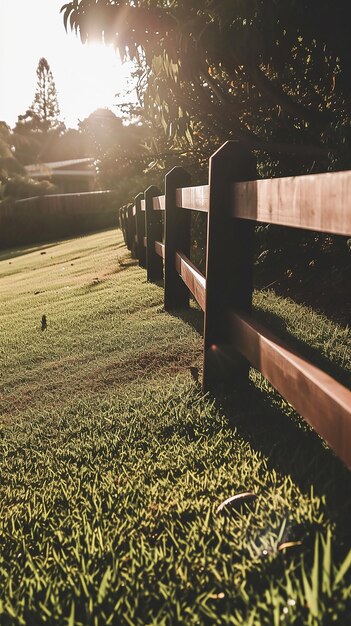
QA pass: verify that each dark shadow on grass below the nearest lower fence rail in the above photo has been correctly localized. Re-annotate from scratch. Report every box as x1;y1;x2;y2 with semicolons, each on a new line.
216;384;351;541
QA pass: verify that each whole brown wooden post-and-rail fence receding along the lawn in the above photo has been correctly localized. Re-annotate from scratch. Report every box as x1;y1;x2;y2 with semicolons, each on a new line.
119;141;351;467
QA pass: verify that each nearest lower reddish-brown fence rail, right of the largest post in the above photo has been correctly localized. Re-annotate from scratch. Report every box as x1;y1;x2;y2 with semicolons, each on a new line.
229;311;351;468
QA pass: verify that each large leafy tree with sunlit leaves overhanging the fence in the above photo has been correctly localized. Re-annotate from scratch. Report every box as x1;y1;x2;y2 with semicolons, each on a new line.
61;0;351;174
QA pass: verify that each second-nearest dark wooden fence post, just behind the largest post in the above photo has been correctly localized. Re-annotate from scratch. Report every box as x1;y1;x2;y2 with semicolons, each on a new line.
164;167;191;311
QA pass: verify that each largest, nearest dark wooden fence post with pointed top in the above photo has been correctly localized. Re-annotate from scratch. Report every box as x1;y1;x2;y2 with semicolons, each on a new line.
203;141;257;391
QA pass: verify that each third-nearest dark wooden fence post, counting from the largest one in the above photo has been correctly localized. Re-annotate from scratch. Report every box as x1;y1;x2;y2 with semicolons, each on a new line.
144;185;163;282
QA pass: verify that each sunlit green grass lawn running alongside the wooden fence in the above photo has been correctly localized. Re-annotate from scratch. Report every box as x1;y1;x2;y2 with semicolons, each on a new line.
0;231;351;626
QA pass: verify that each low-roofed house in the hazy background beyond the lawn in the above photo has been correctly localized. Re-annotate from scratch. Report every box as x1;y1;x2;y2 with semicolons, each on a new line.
25;157;96;193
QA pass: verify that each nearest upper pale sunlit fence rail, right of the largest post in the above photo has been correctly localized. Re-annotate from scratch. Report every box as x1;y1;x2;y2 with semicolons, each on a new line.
232;171;351;236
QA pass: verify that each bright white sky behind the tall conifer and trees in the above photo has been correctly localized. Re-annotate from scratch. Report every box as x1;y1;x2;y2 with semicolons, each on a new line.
0;0;135;128
